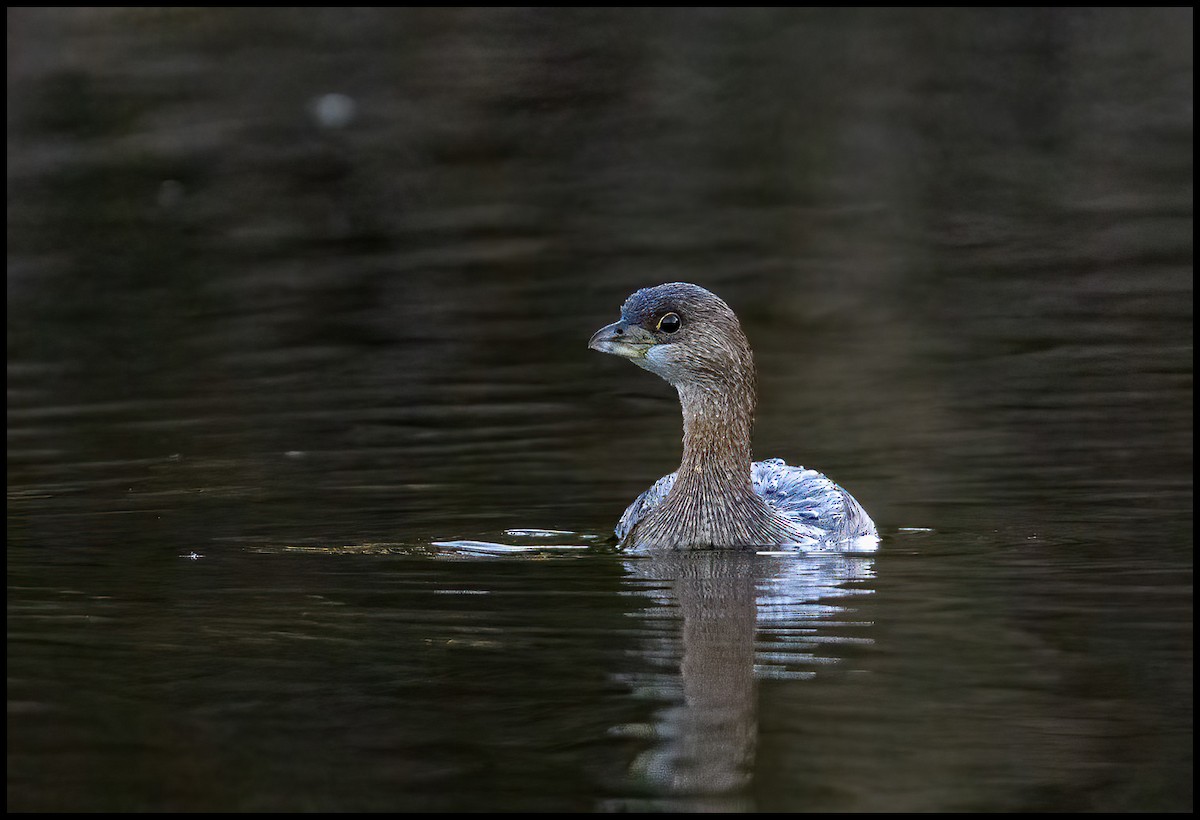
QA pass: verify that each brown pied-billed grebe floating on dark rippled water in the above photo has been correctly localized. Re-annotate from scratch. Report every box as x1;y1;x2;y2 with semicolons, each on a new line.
588;282;878;550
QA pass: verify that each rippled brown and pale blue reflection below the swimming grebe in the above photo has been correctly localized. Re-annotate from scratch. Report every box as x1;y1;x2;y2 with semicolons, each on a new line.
625;551;874;809
